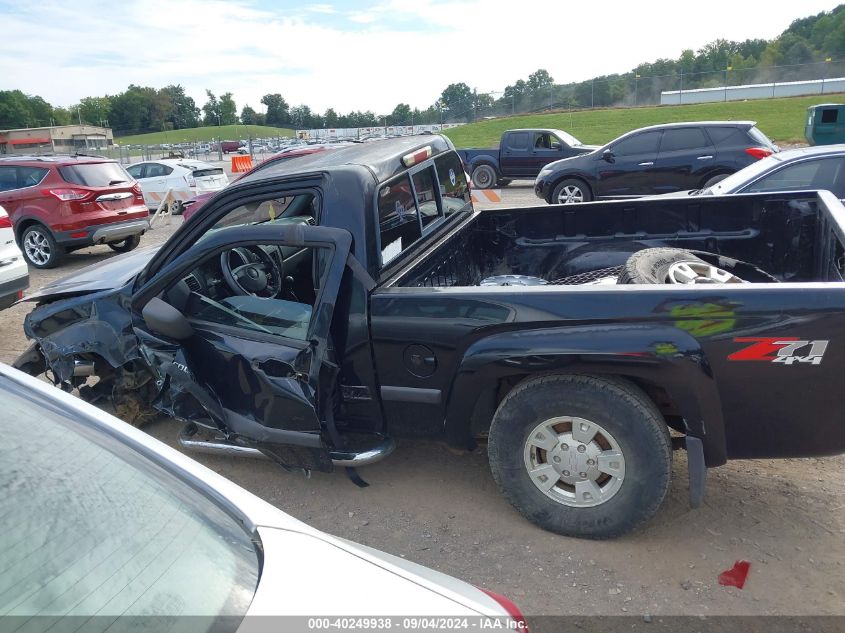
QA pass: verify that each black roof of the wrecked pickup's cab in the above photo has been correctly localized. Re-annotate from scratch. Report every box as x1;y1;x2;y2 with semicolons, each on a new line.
240;134;453;182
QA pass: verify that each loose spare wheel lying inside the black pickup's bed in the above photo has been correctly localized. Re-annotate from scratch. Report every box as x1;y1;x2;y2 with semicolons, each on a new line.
616;248;743;284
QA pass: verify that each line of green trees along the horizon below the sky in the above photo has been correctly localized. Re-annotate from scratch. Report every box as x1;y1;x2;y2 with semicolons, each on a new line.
0;4;845;134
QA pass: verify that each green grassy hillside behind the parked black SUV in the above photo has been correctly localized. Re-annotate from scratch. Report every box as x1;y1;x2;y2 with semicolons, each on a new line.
438;94;845;148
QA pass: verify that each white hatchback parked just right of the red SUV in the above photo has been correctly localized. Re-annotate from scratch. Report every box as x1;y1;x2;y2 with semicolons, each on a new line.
126;159;229;215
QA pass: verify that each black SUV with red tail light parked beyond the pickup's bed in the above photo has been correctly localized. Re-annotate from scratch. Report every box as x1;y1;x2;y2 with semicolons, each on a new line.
534;121;778;204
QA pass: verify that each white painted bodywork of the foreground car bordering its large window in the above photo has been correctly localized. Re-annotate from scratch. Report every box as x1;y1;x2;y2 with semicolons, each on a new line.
0;363;509;631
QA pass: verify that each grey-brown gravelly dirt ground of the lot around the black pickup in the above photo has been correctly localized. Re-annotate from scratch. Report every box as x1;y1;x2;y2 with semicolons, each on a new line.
0;183;845;615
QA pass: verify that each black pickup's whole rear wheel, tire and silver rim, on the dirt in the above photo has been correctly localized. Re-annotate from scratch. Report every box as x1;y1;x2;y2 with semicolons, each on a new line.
487;374;672;539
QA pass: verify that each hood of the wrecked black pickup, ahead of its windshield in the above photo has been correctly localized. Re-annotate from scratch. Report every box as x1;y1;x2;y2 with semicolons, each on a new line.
23;246;160;301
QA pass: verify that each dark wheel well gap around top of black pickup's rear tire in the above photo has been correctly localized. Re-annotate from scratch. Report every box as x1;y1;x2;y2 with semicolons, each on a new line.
470;372;686;438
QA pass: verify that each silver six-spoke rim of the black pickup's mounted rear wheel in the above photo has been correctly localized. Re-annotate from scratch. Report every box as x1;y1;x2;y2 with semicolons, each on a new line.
523;416;625;508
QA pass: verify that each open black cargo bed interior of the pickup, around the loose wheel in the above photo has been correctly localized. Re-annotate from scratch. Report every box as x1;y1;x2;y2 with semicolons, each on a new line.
391;192;845;287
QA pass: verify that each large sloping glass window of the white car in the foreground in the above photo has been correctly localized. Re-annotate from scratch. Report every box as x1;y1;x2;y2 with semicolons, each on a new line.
0;377;259;631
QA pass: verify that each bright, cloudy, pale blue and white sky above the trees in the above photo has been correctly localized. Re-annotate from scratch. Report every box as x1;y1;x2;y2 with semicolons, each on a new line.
0;0;838;114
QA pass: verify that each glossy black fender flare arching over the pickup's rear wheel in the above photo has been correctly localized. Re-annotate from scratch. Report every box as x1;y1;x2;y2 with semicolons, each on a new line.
446;324;727;466
